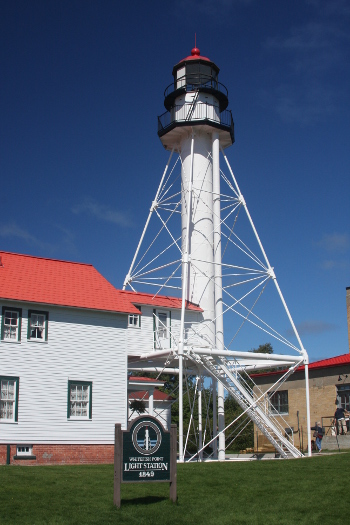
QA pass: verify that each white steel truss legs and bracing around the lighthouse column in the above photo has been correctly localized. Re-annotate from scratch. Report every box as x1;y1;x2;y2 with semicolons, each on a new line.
123;147;311;461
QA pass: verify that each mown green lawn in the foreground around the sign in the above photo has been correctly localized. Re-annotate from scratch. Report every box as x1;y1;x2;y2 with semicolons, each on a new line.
0;453;350;525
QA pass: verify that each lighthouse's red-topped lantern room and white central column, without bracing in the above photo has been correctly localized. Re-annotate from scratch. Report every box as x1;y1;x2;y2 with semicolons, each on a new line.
158;47;234;460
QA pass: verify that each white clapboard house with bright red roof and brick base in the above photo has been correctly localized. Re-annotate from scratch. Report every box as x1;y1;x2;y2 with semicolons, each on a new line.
0;251;201;464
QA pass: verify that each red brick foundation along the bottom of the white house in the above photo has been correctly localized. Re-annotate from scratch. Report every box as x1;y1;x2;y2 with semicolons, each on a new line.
0;444;114;466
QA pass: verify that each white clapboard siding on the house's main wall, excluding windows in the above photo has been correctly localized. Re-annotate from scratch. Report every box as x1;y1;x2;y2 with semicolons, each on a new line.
0;303;127;444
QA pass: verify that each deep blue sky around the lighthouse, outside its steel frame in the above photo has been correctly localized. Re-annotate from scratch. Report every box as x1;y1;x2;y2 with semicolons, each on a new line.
0;0;350;360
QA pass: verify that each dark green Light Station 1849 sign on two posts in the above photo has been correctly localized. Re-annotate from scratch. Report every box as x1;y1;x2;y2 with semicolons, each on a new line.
113;416;177;508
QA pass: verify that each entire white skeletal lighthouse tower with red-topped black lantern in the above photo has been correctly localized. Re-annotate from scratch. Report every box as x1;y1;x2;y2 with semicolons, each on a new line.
124;47;310;461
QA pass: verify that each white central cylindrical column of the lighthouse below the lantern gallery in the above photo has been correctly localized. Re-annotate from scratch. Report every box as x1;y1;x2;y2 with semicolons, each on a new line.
180;128;215;347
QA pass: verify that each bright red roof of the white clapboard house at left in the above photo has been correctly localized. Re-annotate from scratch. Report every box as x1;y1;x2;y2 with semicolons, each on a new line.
0;251;202;314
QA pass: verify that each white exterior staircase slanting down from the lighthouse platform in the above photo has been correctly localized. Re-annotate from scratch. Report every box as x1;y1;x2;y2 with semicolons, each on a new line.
186;350;303;458
